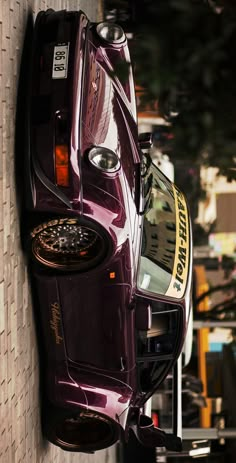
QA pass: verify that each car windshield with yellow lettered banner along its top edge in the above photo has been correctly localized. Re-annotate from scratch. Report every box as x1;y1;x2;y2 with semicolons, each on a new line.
137;163;189;298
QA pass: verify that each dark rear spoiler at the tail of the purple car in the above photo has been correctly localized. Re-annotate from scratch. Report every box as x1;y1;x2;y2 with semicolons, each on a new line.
131;415;182;452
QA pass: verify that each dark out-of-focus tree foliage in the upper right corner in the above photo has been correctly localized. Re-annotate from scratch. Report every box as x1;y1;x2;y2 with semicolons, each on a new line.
133;0;236;180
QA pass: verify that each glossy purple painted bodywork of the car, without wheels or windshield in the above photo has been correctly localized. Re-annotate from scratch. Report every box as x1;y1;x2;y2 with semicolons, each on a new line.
27;11;190;451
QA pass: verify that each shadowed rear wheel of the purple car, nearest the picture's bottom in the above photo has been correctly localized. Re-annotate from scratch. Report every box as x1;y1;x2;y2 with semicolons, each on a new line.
42;402;120;453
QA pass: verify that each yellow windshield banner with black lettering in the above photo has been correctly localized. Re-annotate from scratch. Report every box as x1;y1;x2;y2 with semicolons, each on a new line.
166;185;190;299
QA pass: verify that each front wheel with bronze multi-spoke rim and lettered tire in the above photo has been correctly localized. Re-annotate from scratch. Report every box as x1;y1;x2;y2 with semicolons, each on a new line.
30;217;110;271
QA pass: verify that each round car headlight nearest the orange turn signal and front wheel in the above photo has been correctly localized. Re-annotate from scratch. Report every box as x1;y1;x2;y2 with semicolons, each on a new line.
88;146;120;172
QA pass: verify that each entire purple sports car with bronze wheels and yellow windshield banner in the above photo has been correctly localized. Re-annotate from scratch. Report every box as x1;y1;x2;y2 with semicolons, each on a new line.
25;10;192;452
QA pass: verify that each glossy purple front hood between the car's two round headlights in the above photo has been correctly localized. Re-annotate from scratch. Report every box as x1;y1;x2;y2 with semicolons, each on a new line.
76;27;140;200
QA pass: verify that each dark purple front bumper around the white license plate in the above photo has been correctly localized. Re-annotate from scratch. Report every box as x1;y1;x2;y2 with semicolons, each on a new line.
25;10;89;212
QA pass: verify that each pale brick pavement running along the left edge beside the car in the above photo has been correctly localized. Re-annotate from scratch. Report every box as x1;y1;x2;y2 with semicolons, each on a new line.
0;0;115;463
